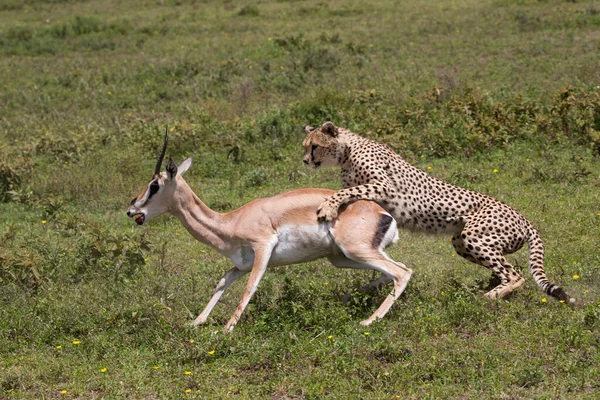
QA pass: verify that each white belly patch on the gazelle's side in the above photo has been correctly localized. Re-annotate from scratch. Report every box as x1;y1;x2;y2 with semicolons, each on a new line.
269;224;337;265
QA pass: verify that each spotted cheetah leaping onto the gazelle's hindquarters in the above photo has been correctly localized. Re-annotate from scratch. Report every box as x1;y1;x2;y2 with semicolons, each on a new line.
303;121;575;304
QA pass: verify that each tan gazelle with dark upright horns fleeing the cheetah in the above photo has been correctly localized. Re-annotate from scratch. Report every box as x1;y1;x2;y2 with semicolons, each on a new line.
127;131;412;332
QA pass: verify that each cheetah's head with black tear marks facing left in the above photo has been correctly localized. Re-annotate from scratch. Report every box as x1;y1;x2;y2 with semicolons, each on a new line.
302;121;342;168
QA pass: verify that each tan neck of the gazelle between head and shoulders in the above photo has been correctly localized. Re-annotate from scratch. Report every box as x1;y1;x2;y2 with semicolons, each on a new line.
170;177;233;254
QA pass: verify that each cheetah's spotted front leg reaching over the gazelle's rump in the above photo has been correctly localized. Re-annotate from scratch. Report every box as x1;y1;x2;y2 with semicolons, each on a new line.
317;183;396;222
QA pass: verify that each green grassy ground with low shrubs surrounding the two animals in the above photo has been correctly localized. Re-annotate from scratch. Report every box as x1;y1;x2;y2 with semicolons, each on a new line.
0;0;600;399
